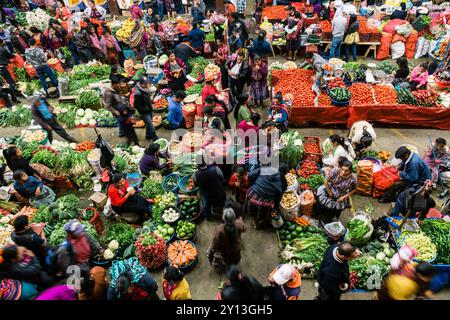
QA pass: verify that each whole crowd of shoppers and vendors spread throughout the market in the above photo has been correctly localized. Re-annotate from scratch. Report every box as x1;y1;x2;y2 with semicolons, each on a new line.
0;0;448;300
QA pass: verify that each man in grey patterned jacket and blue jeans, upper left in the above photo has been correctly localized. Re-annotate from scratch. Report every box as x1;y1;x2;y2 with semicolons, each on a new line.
25;39;58;95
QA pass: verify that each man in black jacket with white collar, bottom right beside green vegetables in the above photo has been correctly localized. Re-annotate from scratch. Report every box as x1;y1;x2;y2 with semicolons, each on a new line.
317;242;361;301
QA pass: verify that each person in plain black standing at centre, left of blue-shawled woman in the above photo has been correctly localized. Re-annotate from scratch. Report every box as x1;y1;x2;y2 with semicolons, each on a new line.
193;156;226;220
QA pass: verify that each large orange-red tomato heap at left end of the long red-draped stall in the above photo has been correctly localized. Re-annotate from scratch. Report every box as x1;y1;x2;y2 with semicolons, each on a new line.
272;69;315;107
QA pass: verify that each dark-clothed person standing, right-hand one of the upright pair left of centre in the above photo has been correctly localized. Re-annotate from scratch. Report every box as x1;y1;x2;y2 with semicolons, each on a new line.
134;77;158;141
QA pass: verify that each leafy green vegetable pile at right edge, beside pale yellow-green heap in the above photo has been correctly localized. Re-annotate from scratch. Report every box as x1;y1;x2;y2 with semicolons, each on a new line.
420;219;450;264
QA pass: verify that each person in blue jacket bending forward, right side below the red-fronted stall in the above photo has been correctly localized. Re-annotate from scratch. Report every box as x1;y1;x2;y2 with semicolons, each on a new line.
378;146;431;203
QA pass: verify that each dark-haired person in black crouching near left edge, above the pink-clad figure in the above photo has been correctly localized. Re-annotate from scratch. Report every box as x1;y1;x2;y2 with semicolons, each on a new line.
11;215;50;268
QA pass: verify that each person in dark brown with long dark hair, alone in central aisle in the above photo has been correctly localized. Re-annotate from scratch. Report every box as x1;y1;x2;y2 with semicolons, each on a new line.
208;208;246;272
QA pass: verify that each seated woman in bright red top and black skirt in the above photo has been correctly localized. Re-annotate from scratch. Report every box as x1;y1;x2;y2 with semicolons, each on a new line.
108;173;151;219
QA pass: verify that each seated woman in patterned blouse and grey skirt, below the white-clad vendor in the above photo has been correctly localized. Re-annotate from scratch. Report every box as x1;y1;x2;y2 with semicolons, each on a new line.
316;161;357;223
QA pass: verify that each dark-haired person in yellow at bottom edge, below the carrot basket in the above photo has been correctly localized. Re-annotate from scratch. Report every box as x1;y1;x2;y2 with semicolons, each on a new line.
162;265;192;300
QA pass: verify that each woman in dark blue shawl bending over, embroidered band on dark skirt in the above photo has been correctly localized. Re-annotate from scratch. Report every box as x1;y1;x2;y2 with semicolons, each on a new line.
244;164;284;228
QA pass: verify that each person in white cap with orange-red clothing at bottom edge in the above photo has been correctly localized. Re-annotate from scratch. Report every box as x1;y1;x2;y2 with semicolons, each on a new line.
268;263;302;300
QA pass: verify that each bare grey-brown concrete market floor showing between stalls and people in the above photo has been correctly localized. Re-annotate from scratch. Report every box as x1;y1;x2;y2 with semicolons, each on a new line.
0;126;450;300
